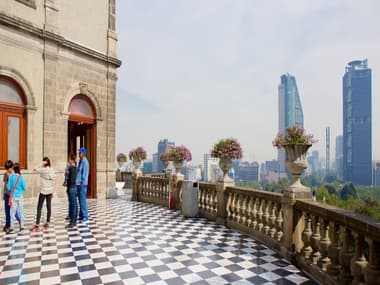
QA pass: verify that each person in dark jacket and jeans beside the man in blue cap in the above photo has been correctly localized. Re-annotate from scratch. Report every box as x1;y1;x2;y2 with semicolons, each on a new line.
67;153;78;228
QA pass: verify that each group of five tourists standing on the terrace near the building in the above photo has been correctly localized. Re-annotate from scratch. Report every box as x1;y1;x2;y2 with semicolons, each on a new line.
3;147;89;233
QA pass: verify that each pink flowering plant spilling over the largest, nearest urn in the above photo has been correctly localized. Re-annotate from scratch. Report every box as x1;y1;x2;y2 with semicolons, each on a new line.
272;126;317;148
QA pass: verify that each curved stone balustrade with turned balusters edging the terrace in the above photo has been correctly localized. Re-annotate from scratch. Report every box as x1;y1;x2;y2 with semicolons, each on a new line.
132;175;380;285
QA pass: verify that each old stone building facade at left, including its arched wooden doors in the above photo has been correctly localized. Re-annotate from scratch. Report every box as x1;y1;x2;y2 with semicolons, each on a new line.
0;0;121;198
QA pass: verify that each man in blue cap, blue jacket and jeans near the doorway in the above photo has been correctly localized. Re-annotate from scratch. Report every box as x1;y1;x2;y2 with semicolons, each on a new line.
76;147;90;223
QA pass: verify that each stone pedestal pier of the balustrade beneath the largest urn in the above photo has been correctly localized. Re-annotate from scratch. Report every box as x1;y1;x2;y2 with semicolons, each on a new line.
281;185;312;258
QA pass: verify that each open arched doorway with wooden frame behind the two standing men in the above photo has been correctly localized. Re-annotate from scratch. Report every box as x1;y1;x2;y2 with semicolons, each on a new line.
67;95;96;198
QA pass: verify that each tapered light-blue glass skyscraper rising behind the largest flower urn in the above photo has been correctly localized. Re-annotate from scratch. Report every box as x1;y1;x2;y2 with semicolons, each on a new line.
278;73;303;172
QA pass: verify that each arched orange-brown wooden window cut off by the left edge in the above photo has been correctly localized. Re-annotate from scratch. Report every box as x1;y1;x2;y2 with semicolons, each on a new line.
0;76;26;168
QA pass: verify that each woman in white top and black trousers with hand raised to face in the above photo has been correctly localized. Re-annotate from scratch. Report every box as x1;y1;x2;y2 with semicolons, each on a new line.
32;157;55;232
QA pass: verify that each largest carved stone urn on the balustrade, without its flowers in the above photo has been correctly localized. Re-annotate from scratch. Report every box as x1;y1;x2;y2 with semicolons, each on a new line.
283;144;311;188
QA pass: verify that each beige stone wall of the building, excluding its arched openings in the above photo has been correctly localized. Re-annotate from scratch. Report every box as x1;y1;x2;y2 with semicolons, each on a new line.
0;0;121;199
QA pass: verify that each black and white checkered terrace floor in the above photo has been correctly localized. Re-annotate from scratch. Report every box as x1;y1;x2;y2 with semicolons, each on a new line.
0;194;316;285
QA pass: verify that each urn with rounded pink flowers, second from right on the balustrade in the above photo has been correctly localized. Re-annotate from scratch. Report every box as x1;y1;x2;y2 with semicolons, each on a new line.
211;138;243;181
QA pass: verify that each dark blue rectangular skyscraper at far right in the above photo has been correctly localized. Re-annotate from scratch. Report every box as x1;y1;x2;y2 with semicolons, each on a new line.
343;60;372;185
